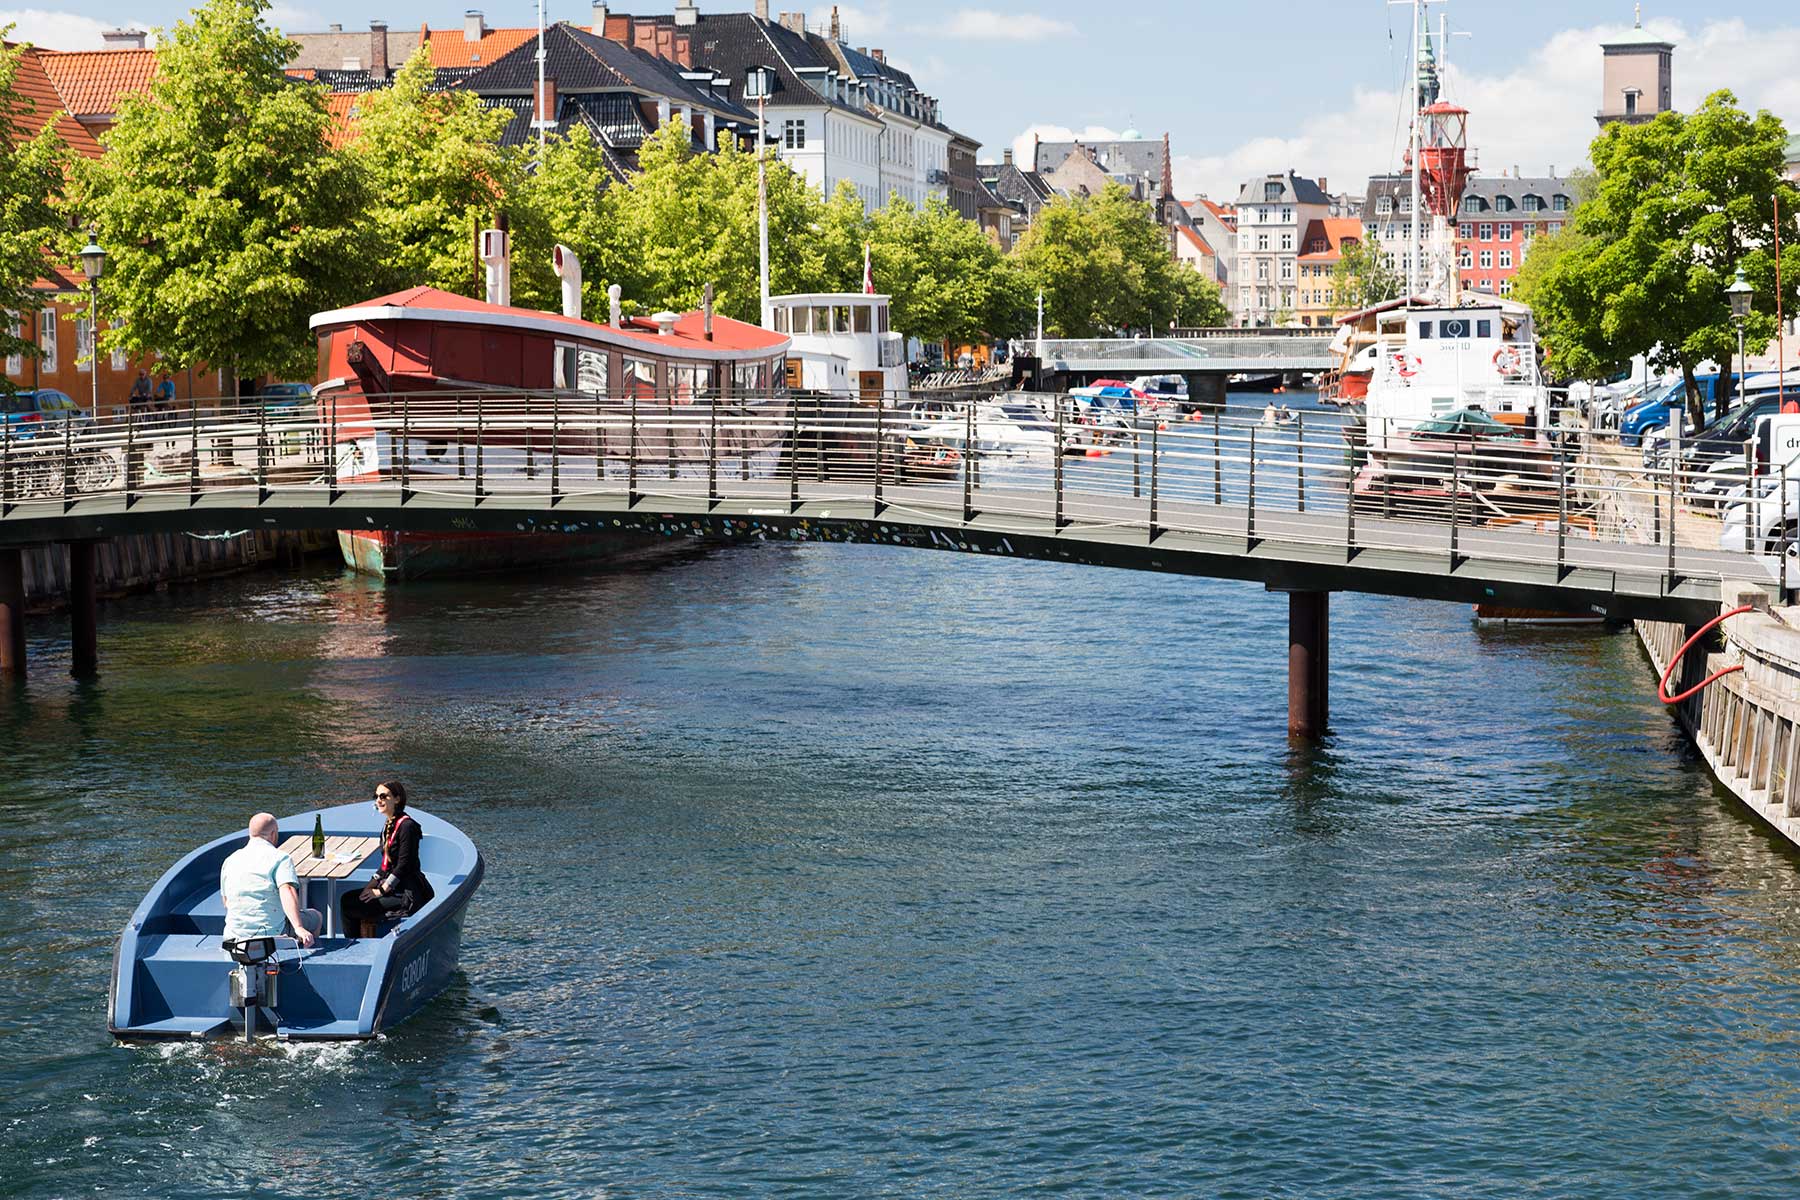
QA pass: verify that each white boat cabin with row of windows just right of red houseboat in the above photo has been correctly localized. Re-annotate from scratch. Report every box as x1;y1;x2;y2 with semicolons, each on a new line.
763;291;907;405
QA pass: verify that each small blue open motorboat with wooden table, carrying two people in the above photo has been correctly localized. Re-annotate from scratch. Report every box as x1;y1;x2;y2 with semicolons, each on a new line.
106;802;484;1042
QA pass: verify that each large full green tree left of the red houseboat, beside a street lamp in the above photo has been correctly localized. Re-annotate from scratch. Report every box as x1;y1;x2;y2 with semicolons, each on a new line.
81;0;378;376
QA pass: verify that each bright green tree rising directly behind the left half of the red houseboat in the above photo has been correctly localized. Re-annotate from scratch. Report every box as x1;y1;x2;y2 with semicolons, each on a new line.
349;45;524;295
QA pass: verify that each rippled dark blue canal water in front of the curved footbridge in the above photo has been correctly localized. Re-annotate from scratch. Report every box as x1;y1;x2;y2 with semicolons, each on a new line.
0;415;1800;1198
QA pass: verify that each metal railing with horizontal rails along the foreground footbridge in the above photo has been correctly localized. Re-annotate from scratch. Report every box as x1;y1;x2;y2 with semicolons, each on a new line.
0;392;1771;587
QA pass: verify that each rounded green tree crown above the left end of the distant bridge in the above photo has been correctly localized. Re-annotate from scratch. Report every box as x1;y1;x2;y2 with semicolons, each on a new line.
1013;184;1228;338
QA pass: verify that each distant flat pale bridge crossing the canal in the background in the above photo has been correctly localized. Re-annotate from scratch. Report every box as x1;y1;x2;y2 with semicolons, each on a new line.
1040;329;1337;376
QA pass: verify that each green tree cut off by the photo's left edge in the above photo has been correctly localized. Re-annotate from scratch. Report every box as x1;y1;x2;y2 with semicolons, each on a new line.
0;38;68;376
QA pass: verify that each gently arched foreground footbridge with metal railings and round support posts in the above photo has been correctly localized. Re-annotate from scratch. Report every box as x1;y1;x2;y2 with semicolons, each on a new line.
0;394;1786;732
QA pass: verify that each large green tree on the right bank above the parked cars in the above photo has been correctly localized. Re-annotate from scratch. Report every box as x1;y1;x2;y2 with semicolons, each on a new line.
1523;92;1800;419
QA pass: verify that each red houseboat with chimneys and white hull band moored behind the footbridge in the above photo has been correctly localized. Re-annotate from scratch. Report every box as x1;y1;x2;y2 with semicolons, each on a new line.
311;230;788;579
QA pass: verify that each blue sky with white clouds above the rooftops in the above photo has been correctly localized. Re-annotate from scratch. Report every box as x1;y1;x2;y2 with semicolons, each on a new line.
17;0;1800;198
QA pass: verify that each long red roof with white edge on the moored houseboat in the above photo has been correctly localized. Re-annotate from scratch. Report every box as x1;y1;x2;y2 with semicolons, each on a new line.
310;288;788;360
